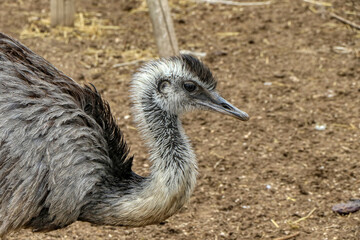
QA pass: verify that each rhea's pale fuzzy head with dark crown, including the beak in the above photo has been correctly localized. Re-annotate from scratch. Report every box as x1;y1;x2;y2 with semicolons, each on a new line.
132;55;249;121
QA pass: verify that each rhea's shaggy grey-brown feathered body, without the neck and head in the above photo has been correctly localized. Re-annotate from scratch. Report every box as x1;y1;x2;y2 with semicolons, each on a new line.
0;34;132;233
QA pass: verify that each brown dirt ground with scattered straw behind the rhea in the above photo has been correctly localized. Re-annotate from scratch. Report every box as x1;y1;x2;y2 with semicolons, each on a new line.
0;0;360;240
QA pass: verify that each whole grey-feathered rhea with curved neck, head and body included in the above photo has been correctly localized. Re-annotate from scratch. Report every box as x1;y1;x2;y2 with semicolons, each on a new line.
0;34;248;236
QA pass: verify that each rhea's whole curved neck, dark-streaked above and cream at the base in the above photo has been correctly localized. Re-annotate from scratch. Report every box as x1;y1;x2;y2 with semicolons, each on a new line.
92;86;197;226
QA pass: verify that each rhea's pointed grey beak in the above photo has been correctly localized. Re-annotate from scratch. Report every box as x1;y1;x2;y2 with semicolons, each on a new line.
196;91;250;121
